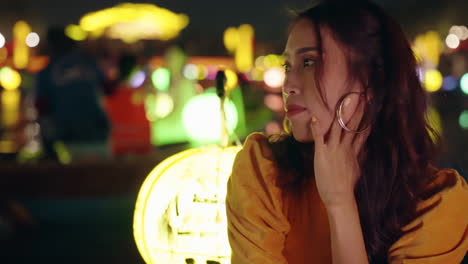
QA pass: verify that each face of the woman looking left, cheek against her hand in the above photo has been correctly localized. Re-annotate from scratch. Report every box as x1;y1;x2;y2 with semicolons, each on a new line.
283;19;357;142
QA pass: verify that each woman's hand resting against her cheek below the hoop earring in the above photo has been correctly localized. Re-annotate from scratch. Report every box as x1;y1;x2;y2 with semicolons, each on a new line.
310;98;369;210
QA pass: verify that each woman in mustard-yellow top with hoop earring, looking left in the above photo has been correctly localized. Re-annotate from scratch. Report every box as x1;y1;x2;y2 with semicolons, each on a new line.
226;1;468;264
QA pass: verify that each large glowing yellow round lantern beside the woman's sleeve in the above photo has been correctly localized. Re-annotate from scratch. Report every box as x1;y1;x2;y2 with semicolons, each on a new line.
133;146;240;264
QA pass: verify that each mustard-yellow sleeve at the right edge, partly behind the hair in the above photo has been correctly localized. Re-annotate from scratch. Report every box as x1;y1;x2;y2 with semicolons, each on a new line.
389;169;468;264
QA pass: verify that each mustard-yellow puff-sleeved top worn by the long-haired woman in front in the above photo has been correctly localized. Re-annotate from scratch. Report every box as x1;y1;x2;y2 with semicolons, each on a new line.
226;133;468;264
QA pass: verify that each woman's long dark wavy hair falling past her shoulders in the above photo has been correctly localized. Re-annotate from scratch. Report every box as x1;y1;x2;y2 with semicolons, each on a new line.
269;1;456;263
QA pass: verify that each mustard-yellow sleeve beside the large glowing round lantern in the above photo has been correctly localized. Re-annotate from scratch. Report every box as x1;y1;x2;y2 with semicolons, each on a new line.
226;133;290;264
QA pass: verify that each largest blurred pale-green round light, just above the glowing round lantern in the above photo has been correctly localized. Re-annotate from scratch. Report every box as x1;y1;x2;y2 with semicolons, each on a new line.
182;92;238;143
